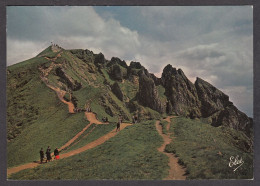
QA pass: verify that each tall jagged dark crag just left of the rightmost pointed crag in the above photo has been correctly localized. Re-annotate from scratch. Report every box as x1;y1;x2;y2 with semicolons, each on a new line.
161;65;201;118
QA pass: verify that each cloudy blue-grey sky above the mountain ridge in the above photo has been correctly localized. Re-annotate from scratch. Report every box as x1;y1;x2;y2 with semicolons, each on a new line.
7;6;253;117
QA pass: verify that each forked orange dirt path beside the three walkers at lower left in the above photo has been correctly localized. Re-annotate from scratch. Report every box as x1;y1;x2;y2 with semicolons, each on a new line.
7;112;132;176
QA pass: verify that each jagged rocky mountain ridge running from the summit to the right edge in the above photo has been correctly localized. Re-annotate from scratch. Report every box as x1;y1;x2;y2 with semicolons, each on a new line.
7;44;253;142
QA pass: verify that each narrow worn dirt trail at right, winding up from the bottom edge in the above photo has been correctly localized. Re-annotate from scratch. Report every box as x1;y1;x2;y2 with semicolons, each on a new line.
155;117;186;180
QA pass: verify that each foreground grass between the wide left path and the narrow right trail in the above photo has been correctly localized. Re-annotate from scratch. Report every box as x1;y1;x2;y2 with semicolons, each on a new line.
11;121;168;180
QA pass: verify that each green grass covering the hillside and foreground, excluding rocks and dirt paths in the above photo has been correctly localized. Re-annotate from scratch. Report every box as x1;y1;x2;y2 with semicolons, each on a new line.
7;46;252;179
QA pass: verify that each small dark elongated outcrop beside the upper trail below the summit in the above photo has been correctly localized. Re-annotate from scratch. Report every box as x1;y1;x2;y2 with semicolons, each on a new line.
55;67;82;91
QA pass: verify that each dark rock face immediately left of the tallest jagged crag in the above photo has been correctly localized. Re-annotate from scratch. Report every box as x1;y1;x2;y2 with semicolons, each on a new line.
138;73;165;113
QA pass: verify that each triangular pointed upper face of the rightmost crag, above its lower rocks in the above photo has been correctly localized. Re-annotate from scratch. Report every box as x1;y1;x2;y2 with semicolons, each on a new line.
195;78;232;117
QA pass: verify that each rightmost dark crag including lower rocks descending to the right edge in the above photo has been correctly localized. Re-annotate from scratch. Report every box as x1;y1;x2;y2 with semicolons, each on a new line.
195;78;253;136
